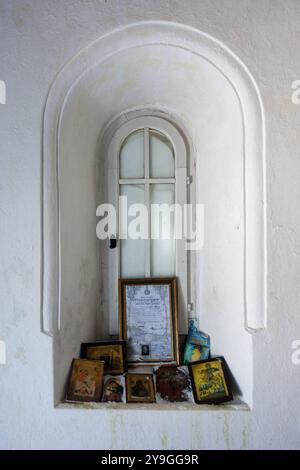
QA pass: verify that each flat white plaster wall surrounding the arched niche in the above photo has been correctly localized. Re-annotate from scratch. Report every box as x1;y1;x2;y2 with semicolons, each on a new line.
0;0;300;449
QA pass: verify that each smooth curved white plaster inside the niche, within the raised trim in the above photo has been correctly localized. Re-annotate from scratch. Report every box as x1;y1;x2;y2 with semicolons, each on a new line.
54;45;252;405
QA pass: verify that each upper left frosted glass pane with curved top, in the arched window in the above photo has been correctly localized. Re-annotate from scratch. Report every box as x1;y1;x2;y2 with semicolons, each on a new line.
120;130;145;178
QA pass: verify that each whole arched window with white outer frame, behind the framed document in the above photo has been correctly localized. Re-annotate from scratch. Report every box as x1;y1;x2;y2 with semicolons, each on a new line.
104;116;188;334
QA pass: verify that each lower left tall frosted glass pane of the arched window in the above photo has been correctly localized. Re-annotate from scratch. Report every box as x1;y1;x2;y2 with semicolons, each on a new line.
119;184;145;277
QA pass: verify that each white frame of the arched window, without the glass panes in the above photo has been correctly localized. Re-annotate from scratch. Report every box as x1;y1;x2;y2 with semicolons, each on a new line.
107;116;188;335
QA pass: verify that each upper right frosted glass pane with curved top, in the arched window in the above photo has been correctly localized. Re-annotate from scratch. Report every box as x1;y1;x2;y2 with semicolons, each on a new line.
149;130;175;178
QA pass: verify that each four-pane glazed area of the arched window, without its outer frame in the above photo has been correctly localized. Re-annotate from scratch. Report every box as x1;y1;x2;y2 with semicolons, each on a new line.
119;127;176;277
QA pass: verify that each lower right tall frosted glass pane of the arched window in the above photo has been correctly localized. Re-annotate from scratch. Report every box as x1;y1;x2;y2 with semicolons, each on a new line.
150;184;175;276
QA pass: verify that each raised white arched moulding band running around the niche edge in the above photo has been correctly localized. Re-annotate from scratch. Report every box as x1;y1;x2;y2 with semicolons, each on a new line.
42;21;267;336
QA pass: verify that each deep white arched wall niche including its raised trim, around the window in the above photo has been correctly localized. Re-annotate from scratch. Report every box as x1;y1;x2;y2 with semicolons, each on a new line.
42;22;266;405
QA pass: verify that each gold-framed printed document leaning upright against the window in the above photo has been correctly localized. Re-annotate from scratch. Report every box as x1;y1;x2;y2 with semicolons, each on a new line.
119;278;179;365
